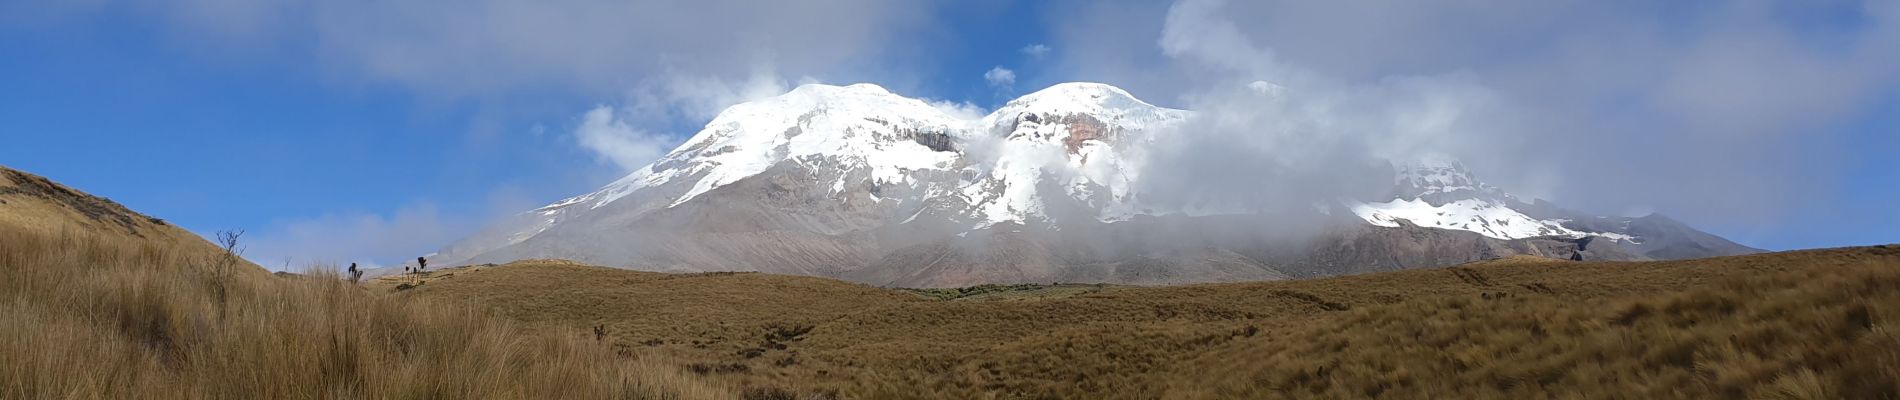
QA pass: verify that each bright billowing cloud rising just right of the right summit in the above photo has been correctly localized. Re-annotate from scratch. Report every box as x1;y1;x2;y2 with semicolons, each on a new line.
1109;2;1492;210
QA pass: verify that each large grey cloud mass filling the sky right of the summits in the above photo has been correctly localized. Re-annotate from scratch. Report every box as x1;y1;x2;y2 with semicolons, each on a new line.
1051;0;1900;231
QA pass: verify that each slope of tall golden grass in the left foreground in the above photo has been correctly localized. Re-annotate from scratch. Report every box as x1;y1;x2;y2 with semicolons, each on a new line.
0;228;732;398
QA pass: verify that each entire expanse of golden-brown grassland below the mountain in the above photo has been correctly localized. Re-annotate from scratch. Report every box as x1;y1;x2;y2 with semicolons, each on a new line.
0;163;1900;398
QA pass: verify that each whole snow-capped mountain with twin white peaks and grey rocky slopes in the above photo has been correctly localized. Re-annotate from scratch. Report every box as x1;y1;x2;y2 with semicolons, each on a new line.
437;83;1752;286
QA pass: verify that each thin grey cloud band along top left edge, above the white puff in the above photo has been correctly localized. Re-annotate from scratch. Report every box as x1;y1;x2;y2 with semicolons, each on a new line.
0;0;937;97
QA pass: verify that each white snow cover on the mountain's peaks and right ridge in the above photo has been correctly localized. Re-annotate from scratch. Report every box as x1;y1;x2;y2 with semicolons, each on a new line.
507;82;1634;248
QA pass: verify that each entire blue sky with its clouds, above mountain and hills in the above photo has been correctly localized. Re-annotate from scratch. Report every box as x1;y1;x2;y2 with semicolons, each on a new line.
0;0;1900;265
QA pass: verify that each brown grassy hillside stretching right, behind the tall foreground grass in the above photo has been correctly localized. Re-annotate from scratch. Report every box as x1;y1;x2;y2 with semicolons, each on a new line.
389;246;1900;398
